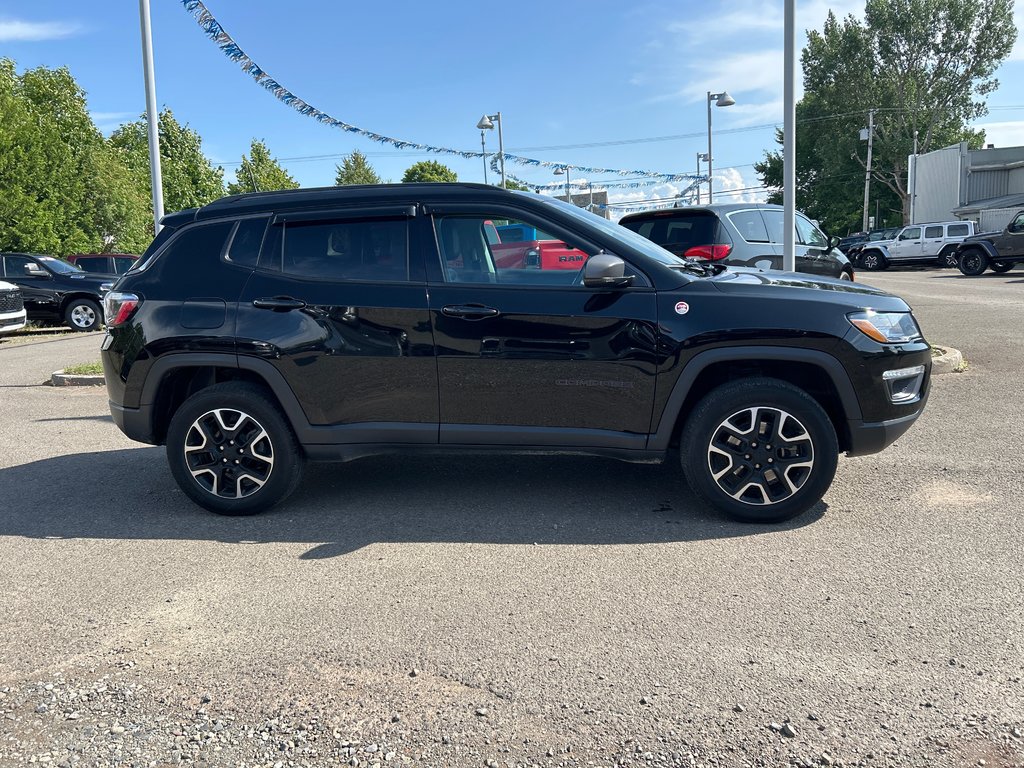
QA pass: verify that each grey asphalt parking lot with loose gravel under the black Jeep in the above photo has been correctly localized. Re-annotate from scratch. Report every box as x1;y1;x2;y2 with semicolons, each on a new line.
0;269;1024;768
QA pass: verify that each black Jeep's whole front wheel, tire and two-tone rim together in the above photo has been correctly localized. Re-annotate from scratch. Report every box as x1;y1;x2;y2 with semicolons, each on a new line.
681;378;839;523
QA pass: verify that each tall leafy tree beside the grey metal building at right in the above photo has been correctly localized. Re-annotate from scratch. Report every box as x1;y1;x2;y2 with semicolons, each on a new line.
757;0;1017;230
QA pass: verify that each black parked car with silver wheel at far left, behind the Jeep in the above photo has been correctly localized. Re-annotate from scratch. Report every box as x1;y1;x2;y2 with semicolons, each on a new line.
0;253;117;331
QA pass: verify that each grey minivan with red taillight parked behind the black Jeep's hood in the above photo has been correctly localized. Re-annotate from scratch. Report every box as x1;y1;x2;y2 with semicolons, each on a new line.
618;203;853;280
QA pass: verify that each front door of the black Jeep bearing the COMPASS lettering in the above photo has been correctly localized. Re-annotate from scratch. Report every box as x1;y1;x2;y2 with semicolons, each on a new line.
427;205;658;449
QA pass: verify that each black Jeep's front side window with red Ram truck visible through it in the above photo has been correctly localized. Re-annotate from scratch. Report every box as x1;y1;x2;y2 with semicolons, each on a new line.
434;214;588;286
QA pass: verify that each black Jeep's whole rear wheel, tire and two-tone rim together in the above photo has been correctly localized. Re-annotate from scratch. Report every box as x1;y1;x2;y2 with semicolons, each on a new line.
167;382;303;515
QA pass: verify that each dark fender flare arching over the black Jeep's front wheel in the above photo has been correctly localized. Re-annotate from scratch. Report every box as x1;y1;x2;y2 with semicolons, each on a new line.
647;346;862;451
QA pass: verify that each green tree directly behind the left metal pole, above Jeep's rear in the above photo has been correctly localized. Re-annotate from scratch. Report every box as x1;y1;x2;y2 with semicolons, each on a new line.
110;108;224;211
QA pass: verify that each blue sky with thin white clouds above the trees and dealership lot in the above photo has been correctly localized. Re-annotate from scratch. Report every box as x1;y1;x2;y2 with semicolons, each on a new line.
0;0;1024;211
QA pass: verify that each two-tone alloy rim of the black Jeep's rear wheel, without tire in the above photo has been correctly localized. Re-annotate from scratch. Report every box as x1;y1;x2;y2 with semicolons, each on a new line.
184;409;273;499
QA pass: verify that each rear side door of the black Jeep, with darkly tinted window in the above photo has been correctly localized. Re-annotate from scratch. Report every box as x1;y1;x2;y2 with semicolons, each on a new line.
237;206;437;443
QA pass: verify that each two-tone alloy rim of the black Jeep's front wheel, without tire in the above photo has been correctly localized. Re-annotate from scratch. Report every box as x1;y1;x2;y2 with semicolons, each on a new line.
708;407;814;506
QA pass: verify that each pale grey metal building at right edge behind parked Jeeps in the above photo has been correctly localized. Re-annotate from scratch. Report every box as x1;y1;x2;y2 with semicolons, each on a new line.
909;141;1024;231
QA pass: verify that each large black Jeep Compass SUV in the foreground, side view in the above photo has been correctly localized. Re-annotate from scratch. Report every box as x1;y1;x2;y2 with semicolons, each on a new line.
101;184;931;522
